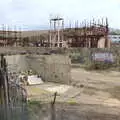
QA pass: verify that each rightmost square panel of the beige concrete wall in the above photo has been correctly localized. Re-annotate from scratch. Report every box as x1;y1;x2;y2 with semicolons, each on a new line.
45;55;71;83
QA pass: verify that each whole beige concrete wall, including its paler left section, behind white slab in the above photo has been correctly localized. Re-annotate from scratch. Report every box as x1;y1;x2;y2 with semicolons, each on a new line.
6;55;71;84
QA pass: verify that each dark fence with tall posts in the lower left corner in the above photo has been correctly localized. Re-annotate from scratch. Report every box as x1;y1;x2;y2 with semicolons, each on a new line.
0;55;27;120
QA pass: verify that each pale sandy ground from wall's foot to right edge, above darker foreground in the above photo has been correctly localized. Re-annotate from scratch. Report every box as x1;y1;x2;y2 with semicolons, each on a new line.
27;68;120;107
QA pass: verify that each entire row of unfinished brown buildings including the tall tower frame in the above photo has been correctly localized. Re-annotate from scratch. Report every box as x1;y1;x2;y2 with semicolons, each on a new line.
0;16;111;48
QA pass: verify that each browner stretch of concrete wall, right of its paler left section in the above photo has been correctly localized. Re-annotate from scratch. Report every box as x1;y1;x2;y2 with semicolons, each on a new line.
27;55;71;84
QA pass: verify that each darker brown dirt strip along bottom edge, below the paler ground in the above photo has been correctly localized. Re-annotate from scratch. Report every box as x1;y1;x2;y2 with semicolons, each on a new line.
30;104;120;120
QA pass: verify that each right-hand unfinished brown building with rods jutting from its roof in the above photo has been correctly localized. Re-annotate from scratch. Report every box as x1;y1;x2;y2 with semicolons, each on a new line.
64;18;110;48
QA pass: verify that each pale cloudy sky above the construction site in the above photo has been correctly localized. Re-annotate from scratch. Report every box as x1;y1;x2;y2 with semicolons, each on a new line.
0;0;120;29
